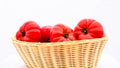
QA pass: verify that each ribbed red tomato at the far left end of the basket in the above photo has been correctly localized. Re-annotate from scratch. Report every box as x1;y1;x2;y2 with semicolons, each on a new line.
16;21;41;42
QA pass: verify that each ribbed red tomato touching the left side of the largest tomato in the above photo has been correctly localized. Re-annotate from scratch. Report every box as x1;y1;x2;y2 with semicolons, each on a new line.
50;24;75;42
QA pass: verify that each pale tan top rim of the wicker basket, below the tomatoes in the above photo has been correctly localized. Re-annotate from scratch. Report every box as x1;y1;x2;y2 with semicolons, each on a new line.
12;35;108;46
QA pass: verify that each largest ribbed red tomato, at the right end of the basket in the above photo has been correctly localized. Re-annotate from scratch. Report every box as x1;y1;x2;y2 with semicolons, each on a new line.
74;19;104;40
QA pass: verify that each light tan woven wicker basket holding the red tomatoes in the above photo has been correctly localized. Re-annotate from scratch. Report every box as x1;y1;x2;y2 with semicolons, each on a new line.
12;36;108;68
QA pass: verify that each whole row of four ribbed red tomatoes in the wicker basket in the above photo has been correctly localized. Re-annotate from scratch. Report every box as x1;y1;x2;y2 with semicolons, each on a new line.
16;19;104;42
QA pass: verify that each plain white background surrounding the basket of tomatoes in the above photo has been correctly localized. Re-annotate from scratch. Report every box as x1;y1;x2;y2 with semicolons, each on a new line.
0;0;120;68
